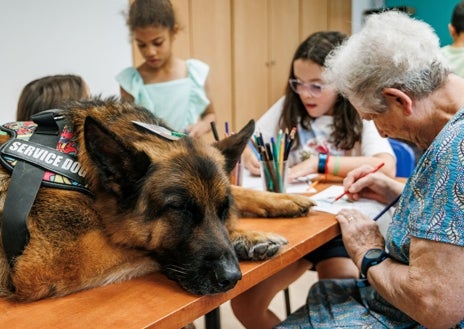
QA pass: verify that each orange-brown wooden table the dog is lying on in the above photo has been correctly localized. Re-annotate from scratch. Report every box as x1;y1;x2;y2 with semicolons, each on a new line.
0;184;340;329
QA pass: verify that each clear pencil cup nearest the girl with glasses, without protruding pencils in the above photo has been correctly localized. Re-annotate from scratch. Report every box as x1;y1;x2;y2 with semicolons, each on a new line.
260;160;288;193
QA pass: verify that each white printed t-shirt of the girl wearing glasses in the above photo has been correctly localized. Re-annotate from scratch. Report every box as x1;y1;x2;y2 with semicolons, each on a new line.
255;96;395;167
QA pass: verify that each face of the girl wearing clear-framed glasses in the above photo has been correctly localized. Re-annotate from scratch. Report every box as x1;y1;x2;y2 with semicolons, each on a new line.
293;59;338;118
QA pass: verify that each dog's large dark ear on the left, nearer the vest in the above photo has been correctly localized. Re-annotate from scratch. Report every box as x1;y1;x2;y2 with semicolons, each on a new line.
84;117;150;198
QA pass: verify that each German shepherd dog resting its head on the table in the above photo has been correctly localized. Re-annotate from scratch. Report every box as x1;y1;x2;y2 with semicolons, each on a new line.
0;97;313;302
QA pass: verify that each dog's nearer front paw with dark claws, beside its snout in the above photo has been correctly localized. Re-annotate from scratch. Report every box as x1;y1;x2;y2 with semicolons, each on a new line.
231;231;288;260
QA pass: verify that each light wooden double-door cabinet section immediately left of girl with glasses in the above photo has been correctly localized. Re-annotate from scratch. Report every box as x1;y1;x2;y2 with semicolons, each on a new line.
232;0;300;127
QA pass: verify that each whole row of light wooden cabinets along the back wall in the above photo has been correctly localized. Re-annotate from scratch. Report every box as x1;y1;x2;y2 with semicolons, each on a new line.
130;0;351;133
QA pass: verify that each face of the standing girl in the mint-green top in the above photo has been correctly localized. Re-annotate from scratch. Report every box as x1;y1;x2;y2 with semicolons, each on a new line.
133;26;174;69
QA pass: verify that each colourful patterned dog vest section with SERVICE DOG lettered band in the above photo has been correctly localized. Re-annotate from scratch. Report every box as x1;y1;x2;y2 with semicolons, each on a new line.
0;121;89;193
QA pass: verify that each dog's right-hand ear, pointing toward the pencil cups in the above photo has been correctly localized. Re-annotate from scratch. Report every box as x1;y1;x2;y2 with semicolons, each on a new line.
215;120;255;172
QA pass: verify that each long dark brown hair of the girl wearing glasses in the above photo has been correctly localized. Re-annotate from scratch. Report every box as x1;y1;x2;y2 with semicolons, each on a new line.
279;31;362;150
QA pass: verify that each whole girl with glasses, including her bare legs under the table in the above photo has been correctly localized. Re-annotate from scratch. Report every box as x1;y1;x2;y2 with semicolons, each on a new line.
231;31;396;329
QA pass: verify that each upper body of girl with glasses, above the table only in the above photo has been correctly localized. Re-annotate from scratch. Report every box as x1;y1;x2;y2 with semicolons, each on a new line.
244;31;396;180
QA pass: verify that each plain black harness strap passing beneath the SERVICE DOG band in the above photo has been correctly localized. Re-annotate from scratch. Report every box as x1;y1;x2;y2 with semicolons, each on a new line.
2;109;66;266
